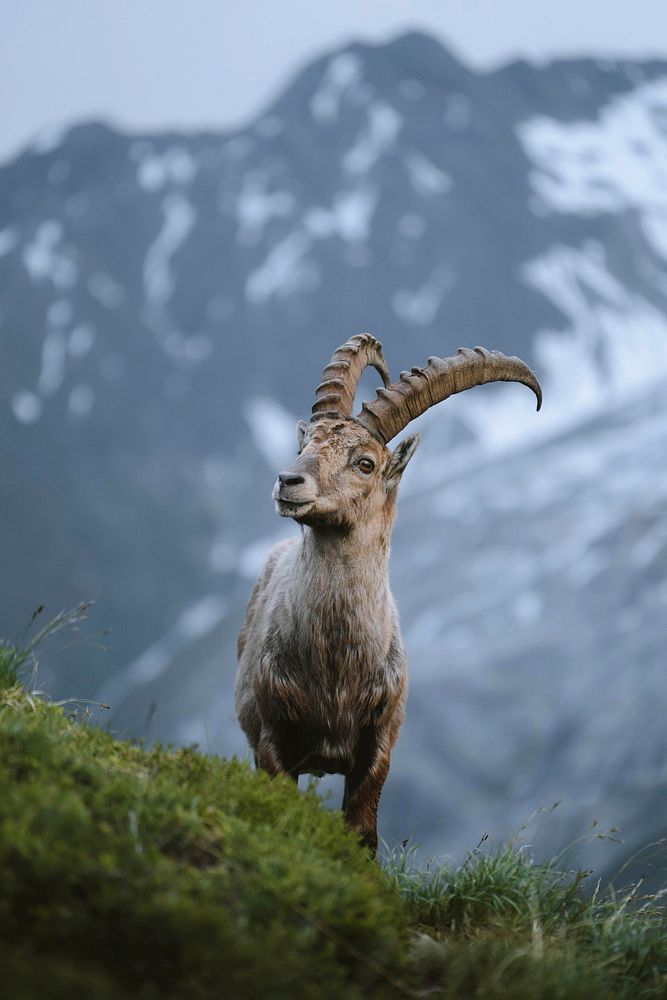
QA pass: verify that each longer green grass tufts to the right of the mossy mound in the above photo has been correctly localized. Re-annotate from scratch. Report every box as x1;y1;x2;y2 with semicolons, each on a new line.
385;824;667;1000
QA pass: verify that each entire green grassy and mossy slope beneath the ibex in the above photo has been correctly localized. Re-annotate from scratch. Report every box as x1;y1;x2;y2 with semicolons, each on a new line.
0;618;667;1000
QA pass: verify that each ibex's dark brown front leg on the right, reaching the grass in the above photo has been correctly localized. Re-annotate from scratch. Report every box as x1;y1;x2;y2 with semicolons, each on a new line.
343;730;390;854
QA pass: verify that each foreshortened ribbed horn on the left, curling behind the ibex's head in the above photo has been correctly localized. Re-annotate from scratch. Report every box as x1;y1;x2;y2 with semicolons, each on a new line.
310;333;390;421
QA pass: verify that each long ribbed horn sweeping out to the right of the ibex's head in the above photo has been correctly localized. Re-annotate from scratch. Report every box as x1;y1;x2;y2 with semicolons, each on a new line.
355;347;542;444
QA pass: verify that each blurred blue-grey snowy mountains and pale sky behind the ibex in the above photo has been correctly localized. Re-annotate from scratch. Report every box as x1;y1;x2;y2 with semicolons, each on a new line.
0;0;667;874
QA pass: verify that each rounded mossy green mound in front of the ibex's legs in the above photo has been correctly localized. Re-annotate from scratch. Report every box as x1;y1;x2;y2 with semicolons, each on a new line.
0;648;407;998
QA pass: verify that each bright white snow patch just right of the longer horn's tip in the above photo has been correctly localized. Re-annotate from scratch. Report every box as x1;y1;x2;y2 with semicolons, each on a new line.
459;241;667;463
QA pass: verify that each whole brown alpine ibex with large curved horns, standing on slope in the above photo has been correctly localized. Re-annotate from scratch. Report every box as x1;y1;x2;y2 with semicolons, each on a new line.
236;333;542;852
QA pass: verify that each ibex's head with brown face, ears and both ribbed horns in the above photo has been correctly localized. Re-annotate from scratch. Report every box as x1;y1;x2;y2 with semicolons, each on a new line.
273;333;542;528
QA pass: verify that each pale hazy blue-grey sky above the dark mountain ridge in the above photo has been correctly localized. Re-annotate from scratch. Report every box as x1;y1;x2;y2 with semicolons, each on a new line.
0;0;667;159
